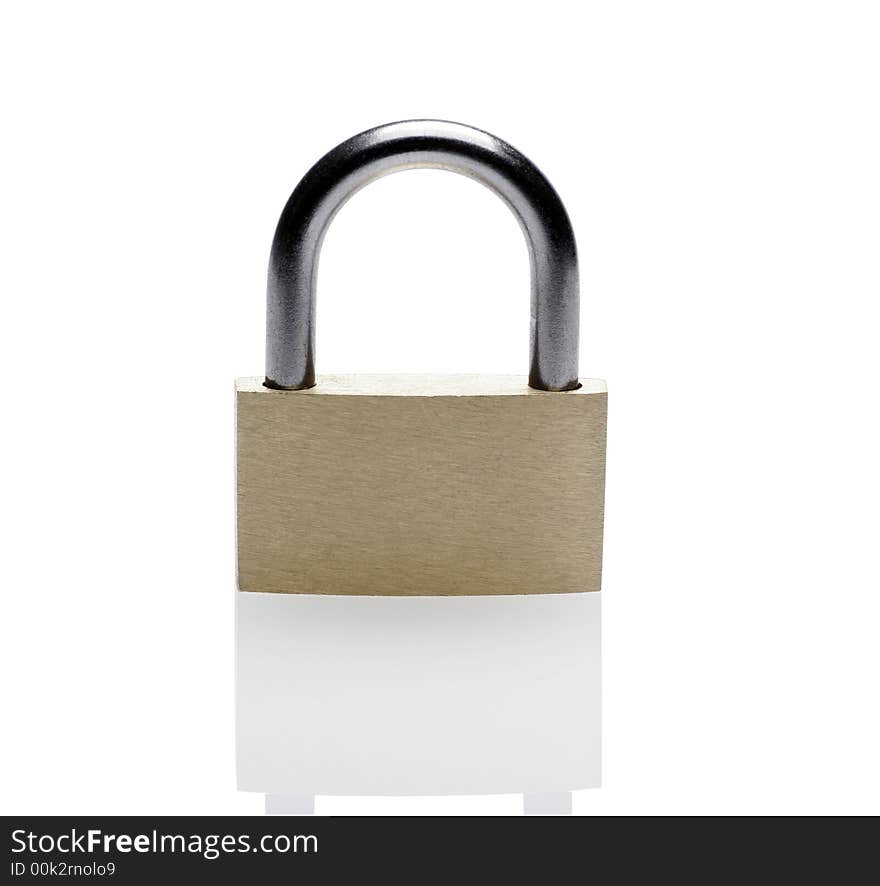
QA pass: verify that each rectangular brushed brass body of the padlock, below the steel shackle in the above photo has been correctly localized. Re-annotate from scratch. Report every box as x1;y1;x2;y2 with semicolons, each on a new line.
236;375;607;596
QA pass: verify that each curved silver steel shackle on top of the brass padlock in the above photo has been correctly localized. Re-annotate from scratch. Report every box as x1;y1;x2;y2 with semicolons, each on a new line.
265;120;579;391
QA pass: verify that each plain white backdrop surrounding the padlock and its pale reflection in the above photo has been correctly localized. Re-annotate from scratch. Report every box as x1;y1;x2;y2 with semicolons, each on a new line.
0;0;880;815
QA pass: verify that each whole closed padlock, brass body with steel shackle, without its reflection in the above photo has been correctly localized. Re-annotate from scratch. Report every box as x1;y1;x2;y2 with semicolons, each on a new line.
236;120;607;595
